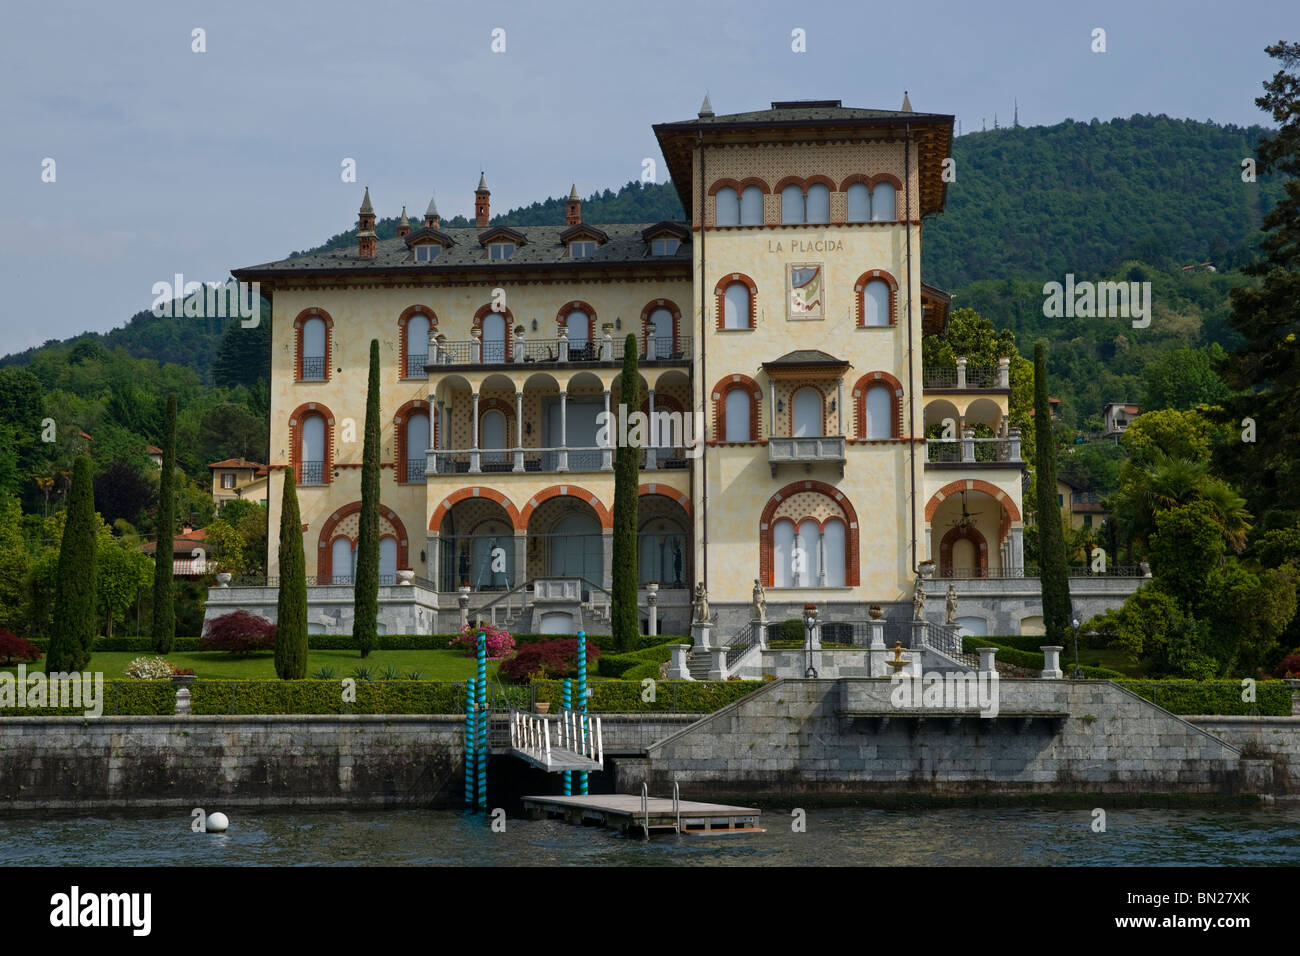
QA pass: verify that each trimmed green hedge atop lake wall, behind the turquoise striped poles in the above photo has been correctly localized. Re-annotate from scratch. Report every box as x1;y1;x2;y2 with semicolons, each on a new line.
187;680;763;715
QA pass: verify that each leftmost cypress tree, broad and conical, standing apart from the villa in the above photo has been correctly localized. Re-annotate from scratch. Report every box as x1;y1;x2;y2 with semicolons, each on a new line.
46;455;99;671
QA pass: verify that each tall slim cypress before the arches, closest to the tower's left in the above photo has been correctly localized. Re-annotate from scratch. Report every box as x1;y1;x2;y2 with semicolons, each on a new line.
611;333;650;650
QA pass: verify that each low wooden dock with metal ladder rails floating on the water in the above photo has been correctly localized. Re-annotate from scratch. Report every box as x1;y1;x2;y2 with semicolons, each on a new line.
523;793;763;836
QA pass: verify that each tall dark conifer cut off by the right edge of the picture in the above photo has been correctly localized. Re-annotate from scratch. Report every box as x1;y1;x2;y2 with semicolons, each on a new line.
1221;42;1300;527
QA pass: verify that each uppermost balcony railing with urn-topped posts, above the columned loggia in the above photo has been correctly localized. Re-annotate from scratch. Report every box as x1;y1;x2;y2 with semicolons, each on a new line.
423;336;692;377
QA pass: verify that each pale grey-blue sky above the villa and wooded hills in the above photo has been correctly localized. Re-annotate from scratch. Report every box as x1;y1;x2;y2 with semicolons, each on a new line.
0;0;1300;355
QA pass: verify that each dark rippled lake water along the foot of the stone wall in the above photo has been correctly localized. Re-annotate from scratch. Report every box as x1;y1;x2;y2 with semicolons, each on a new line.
0;805;1300;866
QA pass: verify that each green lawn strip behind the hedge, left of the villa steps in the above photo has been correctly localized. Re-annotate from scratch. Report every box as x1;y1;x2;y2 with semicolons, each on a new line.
0;650;497;680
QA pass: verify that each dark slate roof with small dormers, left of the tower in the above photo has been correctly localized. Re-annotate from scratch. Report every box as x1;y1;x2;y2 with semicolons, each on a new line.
231;222;692;280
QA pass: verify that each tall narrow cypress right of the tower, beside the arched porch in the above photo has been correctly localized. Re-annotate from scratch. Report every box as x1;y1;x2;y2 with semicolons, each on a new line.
1034;339;1070;646
